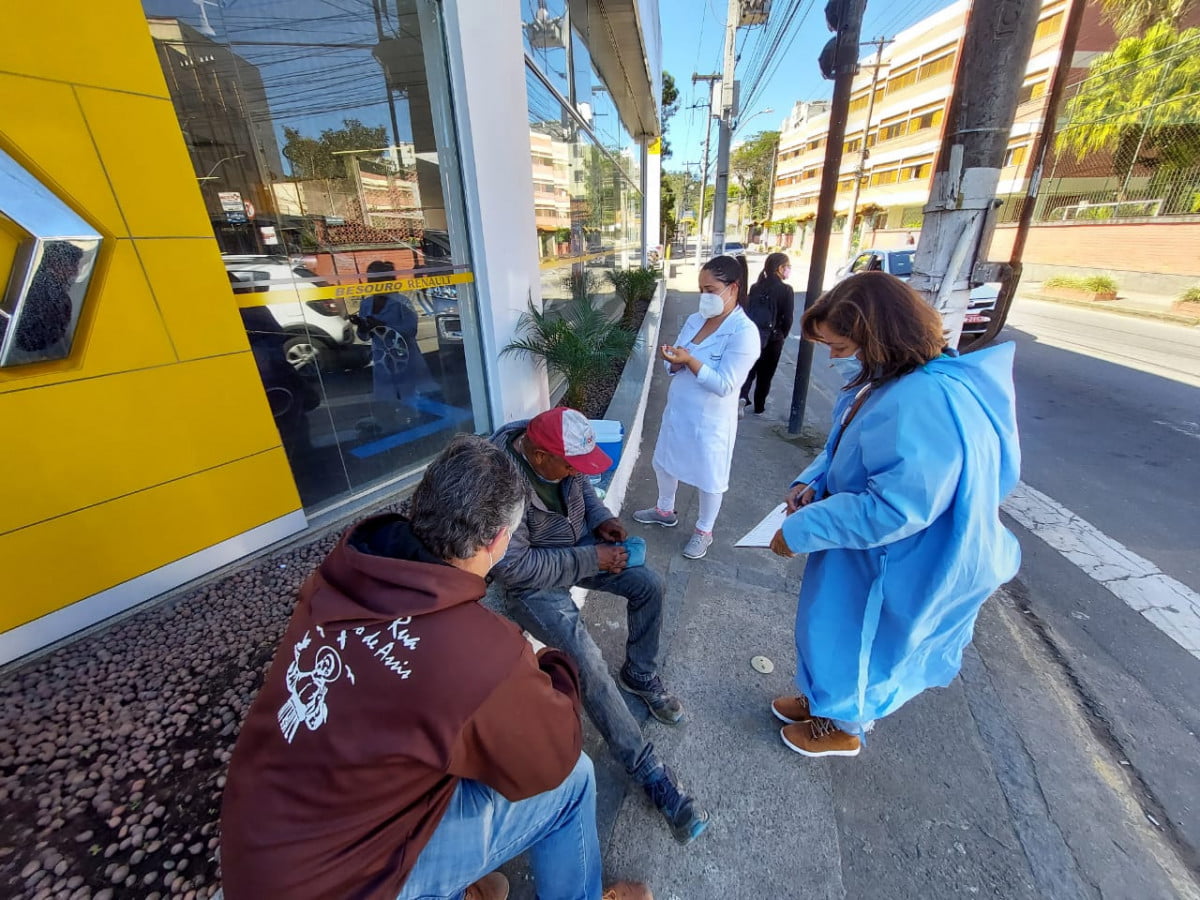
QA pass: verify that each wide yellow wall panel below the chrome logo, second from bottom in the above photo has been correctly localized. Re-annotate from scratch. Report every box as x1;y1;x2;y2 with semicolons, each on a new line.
0;350;280;535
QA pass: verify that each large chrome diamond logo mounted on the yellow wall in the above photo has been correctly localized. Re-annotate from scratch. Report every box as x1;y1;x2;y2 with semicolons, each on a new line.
0;150;103;367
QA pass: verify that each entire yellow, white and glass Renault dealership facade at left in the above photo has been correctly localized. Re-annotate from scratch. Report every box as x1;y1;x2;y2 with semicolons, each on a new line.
0;0;661;662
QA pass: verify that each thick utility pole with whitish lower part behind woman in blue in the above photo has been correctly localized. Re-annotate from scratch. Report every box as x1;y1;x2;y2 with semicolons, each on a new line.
910;0;1042;347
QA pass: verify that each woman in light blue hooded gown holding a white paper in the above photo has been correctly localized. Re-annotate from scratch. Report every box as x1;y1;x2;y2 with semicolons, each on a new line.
772;272;1020;756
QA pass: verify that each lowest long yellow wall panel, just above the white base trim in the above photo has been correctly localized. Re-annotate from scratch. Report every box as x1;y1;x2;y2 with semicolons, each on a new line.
0;449;300;631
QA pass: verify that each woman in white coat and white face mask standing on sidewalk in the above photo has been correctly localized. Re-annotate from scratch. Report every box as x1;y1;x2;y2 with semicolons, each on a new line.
634;256;761;559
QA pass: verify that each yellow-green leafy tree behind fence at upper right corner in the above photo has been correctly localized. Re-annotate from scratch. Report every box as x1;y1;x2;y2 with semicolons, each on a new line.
1056;22;1200;212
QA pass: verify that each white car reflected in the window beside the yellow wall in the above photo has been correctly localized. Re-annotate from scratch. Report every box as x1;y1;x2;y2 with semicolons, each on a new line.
222;254;355;374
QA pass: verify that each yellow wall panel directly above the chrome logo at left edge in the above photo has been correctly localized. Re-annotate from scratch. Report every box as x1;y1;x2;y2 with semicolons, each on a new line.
0;74;128;235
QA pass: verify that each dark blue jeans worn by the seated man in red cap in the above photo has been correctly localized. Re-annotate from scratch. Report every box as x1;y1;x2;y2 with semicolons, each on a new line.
502;566;665;785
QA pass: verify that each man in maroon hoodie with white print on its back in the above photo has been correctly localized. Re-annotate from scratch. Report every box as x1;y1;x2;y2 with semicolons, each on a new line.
221;436;648;900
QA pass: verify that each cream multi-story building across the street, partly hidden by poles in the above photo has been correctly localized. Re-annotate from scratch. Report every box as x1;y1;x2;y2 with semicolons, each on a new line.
770;0;1067;254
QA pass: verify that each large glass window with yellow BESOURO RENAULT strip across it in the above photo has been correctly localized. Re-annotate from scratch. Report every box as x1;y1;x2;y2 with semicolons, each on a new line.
143;0;488;511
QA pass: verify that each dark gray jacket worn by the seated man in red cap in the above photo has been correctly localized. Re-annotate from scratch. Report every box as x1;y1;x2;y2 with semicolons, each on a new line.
492;421;613;590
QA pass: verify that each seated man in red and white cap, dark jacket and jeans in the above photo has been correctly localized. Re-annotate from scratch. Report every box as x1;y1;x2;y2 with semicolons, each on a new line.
492;407;708;844
